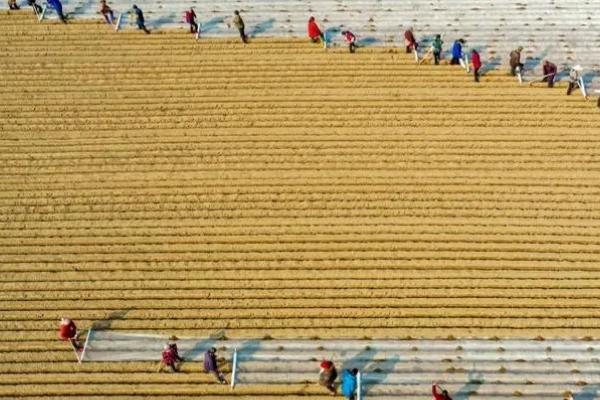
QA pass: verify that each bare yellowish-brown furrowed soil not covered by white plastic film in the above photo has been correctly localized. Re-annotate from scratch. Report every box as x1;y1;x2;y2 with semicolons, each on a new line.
0;8;600;400
